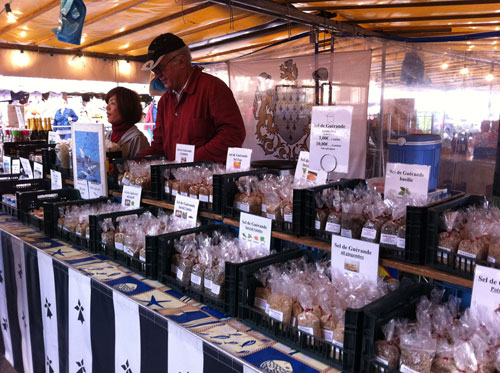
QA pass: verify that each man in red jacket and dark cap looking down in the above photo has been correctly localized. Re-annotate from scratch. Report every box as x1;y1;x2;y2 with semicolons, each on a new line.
140;33;245;163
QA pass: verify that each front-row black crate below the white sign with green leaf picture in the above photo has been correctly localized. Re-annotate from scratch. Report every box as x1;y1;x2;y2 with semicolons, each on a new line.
158;224;294;316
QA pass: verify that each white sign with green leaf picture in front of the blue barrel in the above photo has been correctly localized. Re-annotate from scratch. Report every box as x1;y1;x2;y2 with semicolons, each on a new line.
384;163;431;200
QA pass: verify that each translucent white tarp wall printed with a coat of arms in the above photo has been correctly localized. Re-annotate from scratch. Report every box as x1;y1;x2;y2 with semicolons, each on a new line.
229;51;371;178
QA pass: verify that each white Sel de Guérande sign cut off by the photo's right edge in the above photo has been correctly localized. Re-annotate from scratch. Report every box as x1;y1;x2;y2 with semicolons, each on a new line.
471;264;500;312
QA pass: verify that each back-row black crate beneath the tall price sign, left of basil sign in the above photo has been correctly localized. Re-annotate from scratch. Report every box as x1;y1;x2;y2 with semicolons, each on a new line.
302;179;366;243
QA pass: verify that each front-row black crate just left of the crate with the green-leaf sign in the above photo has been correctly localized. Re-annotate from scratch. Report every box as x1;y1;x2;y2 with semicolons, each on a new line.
89;207;162;279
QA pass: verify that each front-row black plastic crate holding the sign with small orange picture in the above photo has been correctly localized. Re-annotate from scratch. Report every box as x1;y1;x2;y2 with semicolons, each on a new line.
238;249;376;372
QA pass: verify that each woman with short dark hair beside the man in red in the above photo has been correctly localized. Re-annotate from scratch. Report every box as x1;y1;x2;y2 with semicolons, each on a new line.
104;87;149;158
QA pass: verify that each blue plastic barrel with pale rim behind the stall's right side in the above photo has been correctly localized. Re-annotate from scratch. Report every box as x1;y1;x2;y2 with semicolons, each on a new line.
387;134;442;190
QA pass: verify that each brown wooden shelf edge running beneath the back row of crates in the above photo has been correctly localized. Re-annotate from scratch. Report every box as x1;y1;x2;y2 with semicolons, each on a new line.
223;218;472;288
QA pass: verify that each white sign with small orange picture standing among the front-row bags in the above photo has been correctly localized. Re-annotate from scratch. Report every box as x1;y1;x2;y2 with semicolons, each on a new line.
332;235;379;282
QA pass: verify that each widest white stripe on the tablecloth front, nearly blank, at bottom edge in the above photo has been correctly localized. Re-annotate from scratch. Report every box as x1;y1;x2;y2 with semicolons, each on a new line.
167;320;203;373
